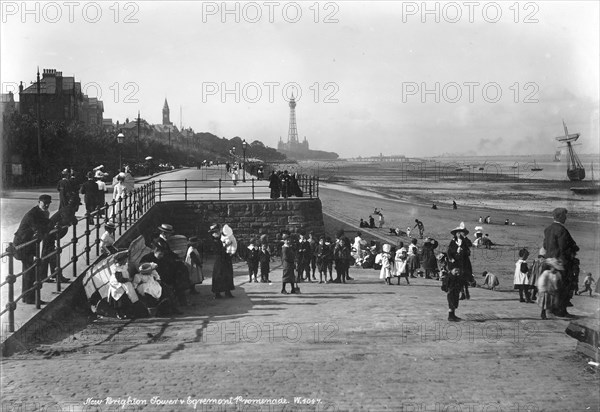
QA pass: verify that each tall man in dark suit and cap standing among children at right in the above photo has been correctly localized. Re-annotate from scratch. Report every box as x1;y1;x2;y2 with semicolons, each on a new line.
543;207;579;316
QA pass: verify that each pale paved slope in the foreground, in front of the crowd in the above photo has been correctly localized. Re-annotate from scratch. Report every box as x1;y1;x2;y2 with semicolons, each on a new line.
1;261;600;411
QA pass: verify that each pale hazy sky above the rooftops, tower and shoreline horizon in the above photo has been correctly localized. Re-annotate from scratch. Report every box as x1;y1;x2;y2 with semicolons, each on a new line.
0;1;600;158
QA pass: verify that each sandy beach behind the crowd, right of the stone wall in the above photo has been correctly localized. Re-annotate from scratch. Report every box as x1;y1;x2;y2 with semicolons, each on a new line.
319;182;600;291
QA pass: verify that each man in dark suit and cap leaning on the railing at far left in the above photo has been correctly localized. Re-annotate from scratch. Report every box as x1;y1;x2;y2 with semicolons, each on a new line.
13;195;52;304
